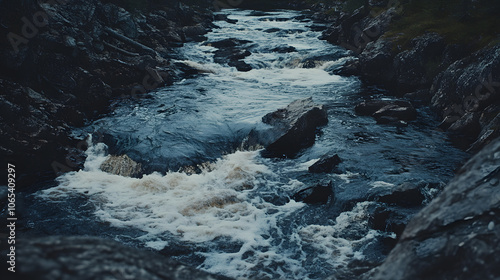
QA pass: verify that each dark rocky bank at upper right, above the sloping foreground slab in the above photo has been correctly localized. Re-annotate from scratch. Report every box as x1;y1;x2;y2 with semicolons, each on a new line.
323;1;500;152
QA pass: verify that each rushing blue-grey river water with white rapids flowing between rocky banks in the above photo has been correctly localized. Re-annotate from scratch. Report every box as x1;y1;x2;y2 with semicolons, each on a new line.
24;10;465;279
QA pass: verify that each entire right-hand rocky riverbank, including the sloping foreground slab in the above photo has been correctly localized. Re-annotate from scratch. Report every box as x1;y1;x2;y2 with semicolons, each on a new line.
308;1;500;279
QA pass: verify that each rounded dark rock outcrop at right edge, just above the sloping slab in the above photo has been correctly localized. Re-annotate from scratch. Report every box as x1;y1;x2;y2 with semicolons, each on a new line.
431;45;500;151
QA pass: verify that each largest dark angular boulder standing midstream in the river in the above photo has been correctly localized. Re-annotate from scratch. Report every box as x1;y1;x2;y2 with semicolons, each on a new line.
243;97;328;157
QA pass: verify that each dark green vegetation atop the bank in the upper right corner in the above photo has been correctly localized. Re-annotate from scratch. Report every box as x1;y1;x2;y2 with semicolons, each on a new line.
385;0;500;49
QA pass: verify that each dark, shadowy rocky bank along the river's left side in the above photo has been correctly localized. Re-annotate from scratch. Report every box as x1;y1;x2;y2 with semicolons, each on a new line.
0;0;213;188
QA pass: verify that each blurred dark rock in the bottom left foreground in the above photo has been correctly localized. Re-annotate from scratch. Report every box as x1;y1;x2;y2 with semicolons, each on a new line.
8;236;229;280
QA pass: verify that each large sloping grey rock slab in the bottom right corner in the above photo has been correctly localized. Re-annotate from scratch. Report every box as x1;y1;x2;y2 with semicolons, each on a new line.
365;138;500;280
